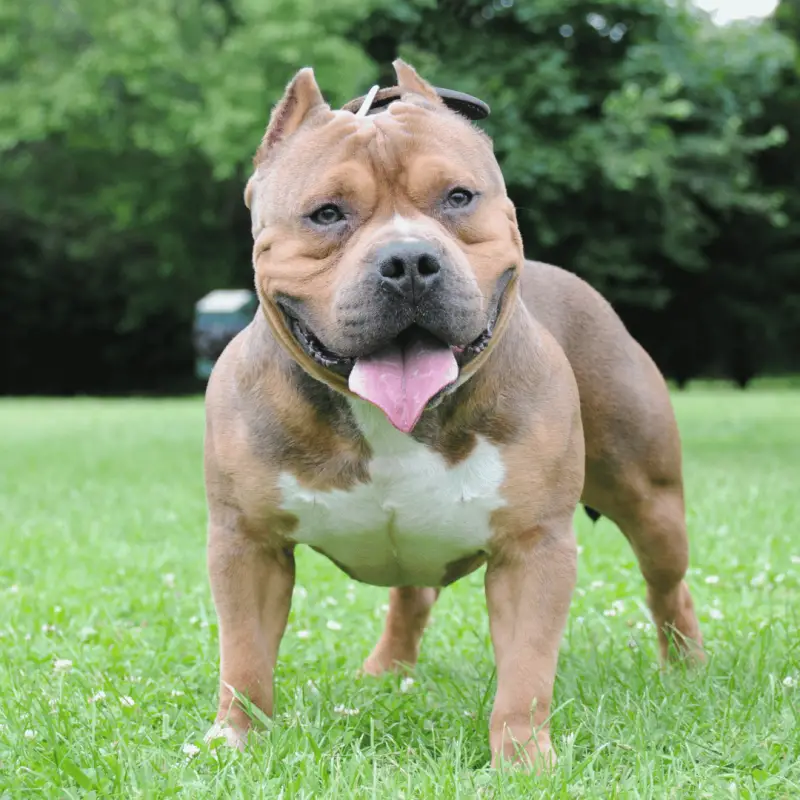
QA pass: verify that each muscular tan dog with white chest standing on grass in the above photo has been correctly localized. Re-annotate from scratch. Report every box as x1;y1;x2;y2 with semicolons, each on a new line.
206;62;701;763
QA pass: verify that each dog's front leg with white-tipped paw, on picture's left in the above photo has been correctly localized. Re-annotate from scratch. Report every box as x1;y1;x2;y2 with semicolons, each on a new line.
208;509;295;748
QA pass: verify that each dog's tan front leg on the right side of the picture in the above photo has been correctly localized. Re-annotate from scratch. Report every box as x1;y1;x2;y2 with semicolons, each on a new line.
486;517;577;769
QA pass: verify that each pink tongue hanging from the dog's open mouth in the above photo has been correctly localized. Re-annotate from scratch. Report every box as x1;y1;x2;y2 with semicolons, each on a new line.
349;334;458;433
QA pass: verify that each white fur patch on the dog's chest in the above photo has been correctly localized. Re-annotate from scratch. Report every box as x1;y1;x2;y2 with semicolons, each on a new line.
279;400;505;586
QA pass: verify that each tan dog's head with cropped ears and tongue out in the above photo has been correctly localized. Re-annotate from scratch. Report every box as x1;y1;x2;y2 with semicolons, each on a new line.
250;61;524;431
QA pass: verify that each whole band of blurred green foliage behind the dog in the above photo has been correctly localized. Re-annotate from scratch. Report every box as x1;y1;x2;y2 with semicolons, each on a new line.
0;0;800;391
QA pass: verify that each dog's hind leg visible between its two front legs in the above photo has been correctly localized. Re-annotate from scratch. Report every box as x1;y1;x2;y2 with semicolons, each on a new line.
362;586;439;675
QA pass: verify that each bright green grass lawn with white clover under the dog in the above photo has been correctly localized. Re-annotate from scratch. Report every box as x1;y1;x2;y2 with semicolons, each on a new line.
0;386;800;800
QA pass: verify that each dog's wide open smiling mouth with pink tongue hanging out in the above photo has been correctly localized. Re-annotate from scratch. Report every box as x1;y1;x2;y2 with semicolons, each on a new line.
279;298;502;433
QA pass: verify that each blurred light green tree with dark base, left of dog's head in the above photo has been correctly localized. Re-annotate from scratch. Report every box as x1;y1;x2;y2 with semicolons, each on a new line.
0;0;373;392
